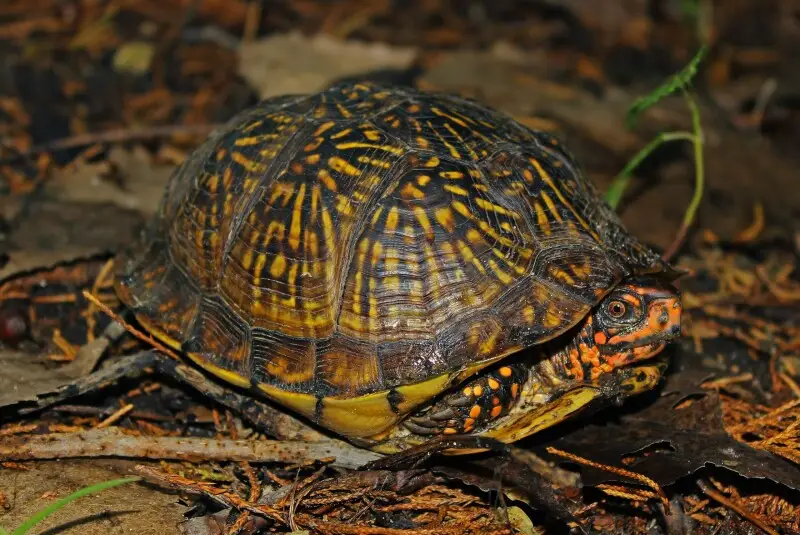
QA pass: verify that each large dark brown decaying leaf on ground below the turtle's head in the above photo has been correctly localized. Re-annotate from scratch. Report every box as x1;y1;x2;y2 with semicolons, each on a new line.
555;351;800;488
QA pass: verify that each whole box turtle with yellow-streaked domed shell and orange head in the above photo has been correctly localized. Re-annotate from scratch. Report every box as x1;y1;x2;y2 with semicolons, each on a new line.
116;82;681;452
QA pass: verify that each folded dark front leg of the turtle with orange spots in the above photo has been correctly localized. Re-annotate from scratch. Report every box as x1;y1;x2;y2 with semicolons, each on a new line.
403;362;530;436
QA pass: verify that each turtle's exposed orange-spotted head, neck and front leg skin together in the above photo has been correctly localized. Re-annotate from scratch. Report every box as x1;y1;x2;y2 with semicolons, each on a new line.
396;277;681;440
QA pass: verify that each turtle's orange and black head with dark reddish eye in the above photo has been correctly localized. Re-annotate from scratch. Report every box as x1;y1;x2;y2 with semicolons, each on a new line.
586;276;681;369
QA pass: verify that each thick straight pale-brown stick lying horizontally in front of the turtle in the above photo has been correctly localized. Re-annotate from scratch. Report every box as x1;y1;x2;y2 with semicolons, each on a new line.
0;428;380;469
